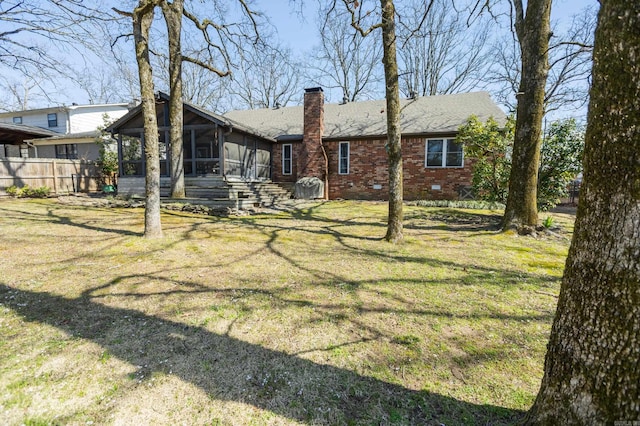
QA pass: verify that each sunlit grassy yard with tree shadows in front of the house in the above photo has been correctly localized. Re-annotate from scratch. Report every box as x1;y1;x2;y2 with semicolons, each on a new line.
0;199;573;425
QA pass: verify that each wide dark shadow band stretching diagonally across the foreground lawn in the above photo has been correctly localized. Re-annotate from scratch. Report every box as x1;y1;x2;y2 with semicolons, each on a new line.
0;284;524;425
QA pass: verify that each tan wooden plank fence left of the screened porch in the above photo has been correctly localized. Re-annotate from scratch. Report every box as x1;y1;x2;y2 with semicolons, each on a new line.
0;157;101;194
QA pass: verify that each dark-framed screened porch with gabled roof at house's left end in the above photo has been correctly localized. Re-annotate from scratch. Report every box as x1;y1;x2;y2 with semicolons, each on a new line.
107;93;275;195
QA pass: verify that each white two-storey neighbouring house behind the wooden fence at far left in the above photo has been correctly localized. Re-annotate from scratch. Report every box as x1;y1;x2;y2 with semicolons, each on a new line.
0;103;129;160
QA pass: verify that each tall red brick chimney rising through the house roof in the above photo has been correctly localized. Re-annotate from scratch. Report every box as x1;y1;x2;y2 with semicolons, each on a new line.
298;87;326;181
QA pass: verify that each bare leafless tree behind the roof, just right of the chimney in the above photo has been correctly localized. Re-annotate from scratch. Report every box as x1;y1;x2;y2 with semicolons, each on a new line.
310;2;382;102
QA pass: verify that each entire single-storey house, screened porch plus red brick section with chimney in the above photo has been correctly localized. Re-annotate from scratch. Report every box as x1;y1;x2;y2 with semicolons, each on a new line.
108;88;506;200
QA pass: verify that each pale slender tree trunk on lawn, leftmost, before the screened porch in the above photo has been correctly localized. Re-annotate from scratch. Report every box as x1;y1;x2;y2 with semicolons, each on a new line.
133;1;162;238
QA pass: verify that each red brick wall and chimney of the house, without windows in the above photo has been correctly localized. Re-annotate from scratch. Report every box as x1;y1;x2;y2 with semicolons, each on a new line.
271;88;471;200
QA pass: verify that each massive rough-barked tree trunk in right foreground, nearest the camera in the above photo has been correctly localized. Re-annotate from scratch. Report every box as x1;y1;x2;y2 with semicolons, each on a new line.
528;0;640;425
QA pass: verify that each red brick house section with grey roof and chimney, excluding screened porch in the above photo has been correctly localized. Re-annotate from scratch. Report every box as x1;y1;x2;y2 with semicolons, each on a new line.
224;88;506;200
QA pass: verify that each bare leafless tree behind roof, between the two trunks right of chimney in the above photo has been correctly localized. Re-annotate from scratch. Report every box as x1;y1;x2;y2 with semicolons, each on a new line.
398;0;492;96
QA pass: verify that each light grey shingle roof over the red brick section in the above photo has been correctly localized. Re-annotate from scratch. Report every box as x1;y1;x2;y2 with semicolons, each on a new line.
224;92;506;140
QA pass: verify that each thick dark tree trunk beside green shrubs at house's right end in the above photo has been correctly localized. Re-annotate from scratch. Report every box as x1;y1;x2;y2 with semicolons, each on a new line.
502;0;551;229
